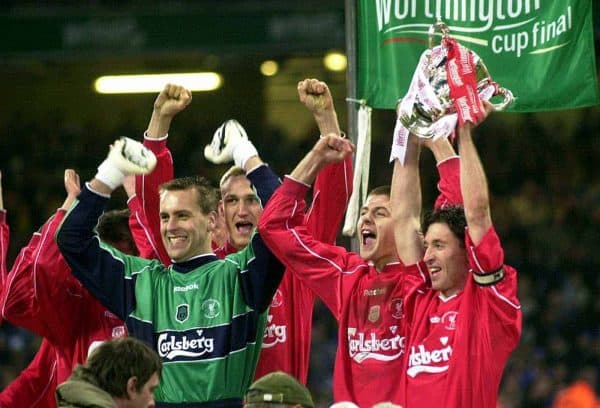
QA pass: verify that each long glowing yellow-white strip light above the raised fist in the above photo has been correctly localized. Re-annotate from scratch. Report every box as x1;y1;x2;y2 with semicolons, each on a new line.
94;72;223;94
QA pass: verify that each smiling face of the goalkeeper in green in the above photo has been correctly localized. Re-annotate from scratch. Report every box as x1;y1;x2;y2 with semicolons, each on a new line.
160;188;215;262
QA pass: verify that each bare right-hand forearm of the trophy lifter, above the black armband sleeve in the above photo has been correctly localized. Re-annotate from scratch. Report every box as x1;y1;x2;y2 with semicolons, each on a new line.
458;102;492;245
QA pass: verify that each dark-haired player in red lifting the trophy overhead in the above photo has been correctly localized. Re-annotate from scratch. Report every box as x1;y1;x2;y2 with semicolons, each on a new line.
392;104;521;408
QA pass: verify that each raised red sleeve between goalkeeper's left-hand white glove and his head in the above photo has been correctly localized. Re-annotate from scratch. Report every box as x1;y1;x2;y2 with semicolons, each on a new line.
135;137;175;266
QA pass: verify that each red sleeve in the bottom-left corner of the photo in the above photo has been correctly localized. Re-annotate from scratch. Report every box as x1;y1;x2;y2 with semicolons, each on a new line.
0;340;57;408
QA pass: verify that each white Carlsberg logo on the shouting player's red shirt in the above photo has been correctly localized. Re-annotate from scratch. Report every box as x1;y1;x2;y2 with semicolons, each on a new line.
348;326;405;363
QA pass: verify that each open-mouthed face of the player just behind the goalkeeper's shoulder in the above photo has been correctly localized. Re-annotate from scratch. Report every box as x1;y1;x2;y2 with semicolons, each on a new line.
219;175;263;250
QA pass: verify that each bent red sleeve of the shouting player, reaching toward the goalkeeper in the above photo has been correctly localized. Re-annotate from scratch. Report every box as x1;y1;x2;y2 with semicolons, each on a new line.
259;177;355;317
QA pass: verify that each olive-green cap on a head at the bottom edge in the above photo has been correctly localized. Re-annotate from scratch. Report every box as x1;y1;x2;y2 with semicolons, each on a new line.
244;371;315;408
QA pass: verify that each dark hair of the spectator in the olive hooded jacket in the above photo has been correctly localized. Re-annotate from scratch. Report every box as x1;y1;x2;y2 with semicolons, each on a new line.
80;337;162;397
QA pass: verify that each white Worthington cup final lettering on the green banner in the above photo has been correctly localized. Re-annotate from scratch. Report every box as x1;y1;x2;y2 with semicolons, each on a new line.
374;0;573;58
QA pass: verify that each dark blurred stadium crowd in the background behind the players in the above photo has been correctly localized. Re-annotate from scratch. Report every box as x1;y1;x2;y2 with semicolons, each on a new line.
0;0;600;408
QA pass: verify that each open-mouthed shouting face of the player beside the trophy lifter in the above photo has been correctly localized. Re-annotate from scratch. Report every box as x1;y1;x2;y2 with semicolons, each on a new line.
357;194;398;270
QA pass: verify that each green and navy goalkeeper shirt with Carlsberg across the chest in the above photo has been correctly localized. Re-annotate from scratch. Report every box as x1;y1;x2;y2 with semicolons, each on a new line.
57;188;283;407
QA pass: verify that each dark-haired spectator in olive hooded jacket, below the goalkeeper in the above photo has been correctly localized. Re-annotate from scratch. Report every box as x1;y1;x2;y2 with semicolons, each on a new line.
56;337;162;408
